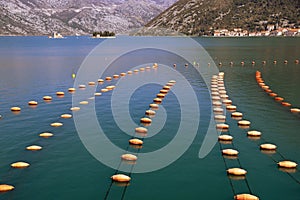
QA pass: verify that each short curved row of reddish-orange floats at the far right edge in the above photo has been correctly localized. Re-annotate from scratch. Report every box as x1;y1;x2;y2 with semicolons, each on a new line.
255;71;300;113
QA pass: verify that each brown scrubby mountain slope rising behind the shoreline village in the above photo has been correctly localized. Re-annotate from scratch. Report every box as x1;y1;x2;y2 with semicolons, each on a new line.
146;0;300;35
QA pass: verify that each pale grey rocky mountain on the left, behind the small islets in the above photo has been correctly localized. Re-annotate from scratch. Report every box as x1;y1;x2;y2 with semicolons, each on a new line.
0;0;176;35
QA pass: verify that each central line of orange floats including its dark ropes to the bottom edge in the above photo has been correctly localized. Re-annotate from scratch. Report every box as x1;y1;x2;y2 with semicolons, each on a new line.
104;77;176;199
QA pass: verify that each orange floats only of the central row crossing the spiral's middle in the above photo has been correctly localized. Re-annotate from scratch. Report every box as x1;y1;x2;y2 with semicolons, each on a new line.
111;77;176;183
